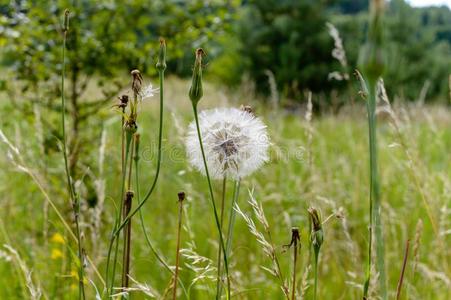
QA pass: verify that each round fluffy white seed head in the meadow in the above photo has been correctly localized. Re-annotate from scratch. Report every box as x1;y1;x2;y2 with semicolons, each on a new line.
186;108;269;179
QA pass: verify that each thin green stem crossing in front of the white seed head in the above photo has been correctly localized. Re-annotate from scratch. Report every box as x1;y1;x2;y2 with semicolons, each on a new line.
193;103;230;299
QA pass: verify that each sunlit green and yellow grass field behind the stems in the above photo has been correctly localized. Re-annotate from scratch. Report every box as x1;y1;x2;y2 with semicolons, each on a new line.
0;78;451;300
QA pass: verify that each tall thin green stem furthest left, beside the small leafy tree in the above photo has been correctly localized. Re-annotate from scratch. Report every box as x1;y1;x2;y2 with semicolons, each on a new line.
61;14;85;299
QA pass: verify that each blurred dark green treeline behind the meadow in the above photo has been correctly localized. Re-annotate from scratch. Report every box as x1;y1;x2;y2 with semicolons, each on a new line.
0;0;451;105
